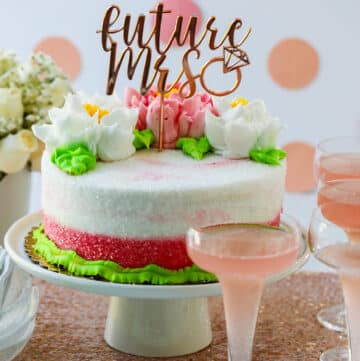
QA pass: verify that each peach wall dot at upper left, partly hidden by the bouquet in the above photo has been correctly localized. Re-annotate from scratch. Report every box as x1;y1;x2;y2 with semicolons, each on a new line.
34;36;81;80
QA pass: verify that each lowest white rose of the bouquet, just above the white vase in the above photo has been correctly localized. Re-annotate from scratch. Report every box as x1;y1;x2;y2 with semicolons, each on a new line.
0;130;38;173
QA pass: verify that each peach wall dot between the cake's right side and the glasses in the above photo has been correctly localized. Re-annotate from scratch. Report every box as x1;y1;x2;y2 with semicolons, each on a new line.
283;142;316;192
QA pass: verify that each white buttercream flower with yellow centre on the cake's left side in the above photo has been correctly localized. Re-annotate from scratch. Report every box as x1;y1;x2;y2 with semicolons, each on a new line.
32;94;137;161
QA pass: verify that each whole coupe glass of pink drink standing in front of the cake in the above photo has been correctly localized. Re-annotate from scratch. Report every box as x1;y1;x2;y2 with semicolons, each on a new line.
187;214;302;361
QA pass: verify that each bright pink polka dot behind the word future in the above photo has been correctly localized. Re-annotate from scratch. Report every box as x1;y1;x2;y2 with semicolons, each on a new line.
152;0;202;47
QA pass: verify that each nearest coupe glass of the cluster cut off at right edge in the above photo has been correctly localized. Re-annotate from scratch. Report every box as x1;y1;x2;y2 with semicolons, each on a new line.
309;201;360;361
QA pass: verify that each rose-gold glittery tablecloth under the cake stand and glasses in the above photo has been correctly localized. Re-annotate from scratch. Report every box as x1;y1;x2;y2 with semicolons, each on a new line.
15;273;346;361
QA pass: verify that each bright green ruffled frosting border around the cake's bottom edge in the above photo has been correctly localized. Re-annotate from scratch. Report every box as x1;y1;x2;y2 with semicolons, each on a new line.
32;226;217;285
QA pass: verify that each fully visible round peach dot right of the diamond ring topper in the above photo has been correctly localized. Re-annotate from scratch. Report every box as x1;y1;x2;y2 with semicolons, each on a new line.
268;38;320;89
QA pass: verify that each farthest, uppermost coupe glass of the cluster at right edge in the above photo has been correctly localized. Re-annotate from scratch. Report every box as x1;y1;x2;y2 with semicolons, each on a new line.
315;136;360;332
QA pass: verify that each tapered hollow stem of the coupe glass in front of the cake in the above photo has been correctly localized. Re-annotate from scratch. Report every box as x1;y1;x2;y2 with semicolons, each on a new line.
219;276;264;361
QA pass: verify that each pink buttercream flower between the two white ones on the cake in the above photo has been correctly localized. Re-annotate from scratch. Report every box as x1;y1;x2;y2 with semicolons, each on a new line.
125;88;217;149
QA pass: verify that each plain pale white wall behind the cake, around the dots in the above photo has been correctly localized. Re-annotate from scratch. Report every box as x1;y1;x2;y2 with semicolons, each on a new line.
0;0;360;270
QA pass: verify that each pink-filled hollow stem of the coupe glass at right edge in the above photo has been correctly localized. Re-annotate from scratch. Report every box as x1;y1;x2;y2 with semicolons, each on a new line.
339;272;360;361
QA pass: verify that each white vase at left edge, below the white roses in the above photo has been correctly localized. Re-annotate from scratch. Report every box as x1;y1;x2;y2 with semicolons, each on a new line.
0;169;31;245
